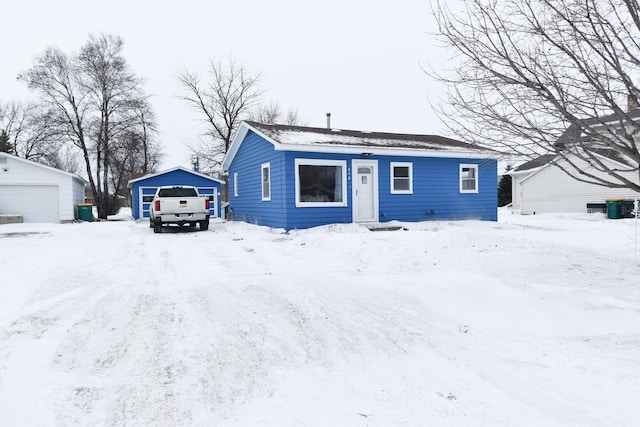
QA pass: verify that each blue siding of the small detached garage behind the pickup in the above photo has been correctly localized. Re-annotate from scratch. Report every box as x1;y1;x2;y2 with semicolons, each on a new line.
131;169;220;219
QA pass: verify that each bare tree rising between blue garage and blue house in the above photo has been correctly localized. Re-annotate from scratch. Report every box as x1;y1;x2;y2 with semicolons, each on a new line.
178;59;263;169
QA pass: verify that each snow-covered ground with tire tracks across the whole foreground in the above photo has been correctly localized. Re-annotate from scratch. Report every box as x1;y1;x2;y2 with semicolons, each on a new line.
0;211;640;426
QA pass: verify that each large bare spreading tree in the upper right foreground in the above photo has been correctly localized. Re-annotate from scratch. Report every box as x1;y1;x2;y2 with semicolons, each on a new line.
430;0;640;191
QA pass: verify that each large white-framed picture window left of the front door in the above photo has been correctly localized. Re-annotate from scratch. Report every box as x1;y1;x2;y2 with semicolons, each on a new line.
295;159;347;207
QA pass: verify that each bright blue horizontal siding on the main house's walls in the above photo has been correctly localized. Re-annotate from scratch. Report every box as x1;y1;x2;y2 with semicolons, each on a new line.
229;131;498;230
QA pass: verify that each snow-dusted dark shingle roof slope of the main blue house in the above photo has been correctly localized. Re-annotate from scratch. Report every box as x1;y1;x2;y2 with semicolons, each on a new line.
247;122;491;152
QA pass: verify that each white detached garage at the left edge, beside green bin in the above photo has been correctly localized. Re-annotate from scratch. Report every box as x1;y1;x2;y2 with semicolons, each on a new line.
0;153;87;223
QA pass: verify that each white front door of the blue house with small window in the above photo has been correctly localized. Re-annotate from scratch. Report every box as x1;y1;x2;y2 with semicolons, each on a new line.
351;160;378;222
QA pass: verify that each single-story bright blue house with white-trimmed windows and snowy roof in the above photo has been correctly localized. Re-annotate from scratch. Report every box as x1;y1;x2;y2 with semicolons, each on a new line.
223;121;498;230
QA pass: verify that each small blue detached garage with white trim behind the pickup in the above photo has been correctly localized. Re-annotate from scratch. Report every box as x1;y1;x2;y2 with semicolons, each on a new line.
127;167;223;219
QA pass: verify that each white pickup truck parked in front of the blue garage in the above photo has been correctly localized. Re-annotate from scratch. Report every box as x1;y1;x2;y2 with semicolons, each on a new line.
149;185;209;233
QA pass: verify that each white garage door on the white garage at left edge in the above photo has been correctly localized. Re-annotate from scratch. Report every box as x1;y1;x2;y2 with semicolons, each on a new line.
0;185;60;222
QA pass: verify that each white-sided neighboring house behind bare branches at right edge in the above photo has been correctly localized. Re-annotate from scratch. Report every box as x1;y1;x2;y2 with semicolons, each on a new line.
509;104;640;214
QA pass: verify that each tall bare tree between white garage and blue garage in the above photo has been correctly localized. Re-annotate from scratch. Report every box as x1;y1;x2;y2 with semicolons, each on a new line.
19;34;157;218
